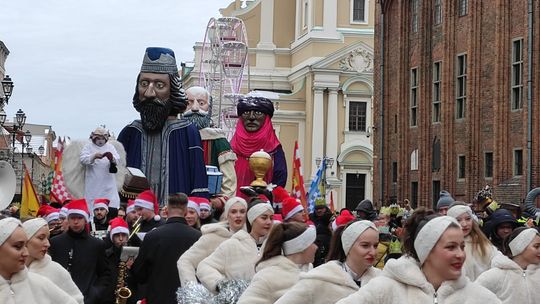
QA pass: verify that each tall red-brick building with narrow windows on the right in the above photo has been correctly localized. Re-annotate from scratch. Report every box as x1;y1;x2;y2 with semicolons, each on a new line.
374;0;540;207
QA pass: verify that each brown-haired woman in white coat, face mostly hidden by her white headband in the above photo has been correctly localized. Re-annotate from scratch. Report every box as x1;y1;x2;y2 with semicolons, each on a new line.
238;222;317;304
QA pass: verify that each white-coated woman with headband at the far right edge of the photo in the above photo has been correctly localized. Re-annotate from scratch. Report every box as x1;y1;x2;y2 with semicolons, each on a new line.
476;227;540;304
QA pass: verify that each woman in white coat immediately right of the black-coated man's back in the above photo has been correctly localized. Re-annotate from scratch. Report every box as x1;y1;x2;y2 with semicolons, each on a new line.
176;197;247;286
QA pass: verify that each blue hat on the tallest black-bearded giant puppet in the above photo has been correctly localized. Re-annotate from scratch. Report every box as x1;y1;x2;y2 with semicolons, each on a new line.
141;47;178;74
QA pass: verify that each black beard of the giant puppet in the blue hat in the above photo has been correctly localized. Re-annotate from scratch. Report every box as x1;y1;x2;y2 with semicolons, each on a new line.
133;97;172;132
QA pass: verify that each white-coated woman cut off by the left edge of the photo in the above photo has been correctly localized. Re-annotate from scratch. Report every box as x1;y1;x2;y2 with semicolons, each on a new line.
0;217;77;304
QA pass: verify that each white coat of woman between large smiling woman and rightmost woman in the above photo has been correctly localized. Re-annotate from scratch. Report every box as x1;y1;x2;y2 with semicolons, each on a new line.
463;236;502;281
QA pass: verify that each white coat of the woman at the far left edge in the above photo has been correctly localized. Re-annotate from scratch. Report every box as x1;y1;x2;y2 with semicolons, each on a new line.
0;268;77;304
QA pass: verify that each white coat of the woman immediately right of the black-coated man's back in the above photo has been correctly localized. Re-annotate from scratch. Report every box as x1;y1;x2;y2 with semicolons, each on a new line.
176;222;233;286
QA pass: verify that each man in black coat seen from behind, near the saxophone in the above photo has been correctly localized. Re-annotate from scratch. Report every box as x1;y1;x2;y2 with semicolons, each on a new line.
131;193;201;304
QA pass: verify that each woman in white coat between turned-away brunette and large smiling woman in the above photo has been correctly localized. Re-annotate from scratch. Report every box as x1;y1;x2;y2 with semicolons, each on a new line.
276;220;381;304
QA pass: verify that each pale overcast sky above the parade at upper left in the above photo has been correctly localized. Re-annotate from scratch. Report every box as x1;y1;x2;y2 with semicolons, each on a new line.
0;0;228;139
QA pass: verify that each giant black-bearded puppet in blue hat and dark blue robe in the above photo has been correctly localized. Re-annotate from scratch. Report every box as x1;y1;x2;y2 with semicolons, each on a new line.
118;47;208;205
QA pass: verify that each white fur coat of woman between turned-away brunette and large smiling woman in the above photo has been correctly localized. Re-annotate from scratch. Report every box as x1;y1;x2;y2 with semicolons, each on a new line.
276;261;381;304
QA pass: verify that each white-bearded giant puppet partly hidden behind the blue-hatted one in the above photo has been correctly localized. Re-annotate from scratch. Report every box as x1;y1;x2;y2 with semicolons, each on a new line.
183;86;236;197
